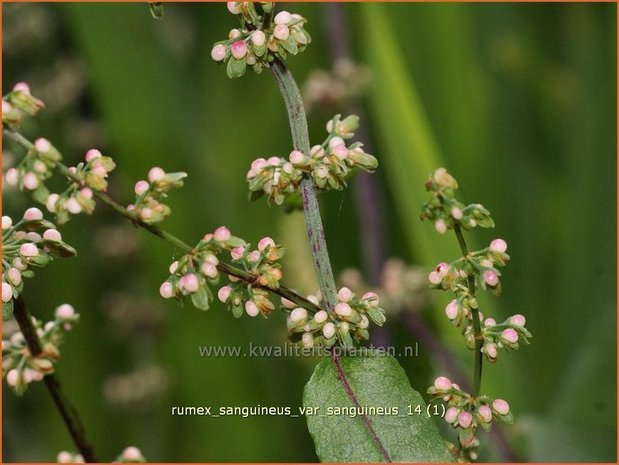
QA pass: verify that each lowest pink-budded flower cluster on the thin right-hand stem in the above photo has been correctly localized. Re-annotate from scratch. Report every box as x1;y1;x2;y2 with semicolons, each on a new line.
428;376;513;460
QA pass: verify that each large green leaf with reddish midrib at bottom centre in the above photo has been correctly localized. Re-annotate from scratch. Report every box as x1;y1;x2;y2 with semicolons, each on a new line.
303;355;452;462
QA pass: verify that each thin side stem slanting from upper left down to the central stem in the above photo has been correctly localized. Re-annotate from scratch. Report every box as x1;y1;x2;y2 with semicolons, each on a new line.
4;128;320;313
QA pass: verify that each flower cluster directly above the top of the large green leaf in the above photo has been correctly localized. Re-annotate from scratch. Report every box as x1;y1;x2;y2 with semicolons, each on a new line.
282;287;385;349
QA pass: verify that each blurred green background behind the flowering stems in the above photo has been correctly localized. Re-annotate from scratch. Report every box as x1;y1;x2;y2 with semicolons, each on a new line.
2;3;617;462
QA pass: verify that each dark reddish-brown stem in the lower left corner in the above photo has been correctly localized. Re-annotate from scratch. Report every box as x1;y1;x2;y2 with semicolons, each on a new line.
14;297;97;462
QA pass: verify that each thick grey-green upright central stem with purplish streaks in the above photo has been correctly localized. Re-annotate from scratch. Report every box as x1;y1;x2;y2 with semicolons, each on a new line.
271;59;337;311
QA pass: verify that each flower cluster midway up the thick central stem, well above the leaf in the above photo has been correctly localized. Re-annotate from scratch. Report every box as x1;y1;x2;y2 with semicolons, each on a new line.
247;115;378;205
